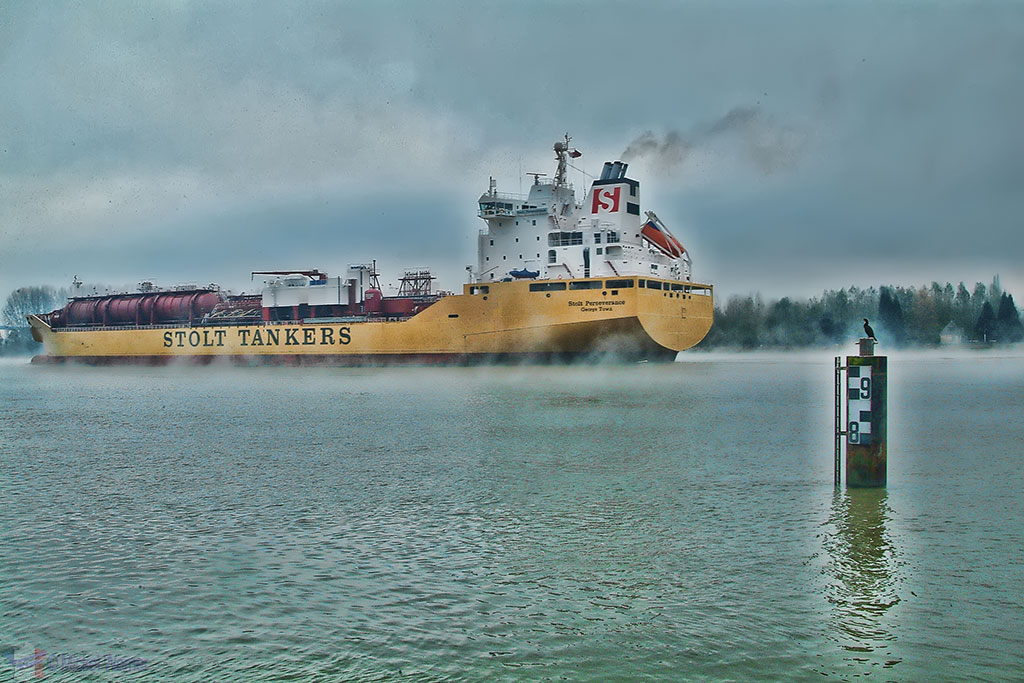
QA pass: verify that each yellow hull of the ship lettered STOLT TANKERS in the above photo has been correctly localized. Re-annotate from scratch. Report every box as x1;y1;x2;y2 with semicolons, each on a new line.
29;278;714;362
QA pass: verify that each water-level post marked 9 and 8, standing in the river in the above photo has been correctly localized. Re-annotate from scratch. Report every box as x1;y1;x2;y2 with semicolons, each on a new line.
836;339;888;487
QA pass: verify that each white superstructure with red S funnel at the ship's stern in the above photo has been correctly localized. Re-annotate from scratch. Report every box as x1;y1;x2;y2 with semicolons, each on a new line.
473;135;690;282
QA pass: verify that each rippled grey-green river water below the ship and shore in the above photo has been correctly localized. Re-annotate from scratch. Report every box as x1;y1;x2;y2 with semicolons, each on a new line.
0;353;1024;681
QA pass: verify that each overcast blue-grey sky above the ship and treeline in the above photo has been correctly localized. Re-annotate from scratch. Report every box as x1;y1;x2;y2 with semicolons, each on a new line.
0;0;1024;298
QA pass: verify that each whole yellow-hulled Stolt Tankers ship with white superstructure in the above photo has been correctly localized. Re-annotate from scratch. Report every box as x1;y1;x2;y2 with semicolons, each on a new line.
28;135;714;365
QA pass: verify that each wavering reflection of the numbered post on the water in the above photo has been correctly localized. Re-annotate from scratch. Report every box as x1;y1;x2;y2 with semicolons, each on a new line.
823;488;902;667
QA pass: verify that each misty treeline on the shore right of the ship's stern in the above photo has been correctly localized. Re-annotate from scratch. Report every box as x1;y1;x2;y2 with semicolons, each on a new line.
697;276;1024;349
